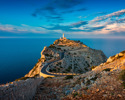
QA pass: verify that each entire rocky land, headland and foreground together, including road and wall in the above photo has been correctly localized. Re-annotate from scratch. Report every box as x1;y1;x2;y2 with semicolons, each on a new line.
0;38;125;100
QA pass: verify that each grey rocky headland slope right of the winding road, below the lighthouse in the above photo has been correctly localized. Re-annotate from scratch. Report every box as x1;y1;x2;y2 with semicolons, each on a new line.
49;39;107;73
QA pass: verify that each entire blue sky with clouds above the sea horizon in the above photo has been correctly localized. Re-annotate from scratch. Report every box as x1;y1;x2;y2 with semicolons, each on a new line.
0;0;125;38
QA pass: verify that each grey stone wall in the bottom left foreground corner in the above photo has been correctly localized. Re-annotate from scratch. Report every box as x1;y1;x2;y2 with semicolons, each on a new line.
0;78;43;100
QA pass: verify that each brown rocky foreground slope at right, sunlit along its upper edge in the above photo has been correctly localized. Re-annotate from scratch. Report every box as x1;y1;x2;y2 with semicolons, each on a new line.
34;51;125;100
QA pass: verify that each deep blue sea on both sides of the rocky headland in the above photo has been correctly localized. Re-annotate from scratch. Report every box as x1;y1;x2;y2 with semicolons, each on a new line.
0;38;125;84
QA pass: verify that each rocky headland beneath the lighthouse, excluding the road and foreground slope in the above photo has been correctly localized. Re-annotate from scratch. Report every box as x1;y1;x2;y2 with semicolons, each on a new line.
25;38;107;77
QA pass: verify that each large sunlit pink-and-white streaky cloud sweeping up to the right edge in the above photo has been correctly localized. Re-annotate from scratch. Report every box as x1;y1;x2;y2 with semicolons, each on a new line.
40;10;125;35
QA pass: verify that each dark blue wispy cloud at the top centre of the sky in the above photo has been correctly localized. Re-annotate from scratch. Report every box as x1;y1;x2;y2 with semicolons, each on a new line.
31;0;87;24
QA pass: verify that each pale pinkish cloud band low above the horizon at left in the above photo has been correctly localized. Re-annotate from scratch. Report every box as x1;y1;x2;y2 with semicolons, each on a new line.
0;24;48;33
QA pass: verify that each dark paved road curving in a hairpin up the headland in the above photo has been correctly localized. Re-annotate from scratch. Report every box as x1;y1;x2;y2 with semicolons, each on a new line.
41;52;65;76
